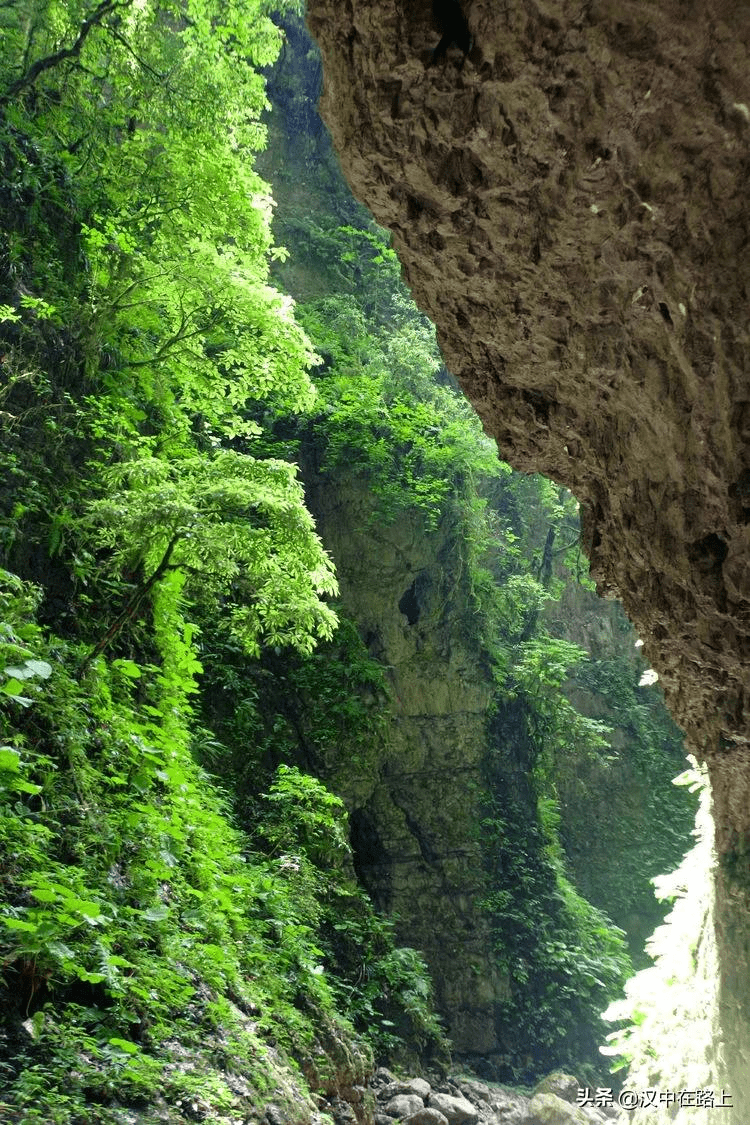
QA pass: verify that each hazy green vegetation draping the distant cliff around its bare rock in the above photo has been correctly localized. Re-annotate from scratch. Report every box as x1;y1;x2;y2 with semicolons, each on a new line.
254;15;692;1079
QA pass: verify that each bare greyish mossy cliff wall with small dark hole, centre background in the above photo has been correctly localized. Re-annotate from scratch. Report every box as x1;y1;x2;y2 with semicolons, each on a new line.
305;473;503;1054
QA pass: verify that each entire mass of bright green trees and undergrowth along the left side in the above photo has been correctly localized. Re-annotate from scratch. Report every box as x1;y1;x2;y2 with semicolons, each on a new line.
0;0;439;1122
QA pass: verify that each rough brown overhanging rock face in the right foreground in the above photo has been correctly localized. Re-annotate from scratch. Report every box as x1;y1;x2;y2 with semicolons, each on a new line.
308;0;750;1105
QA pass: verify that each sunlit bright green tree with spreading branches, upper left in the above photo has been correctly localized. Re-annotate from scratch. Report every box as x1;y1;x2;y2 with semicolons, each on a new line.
0;0;335;653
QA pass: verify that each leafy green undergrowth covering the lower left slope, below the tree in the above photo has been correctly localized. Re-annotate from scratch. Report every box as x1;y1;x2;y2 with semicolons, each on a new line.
0;573;357;1123
